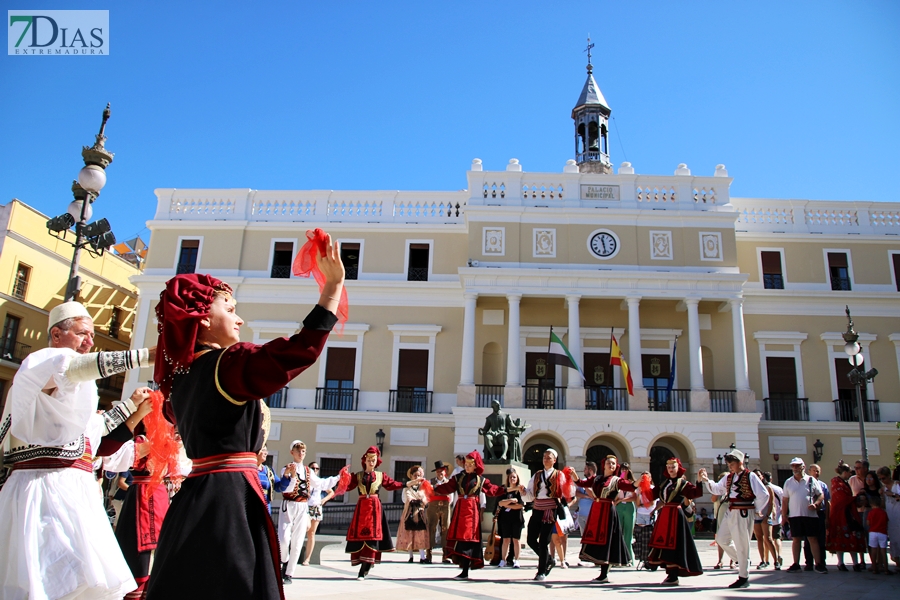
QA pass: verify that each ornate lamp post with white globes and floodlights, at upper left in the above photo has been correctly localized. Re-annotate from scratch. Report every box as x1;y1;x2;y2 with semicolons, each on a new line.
47;104;116;302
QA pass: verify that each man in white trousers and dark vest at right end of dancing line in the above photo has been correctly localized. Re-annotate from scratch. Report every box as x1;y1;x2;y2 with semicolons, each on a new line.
699;448;769;588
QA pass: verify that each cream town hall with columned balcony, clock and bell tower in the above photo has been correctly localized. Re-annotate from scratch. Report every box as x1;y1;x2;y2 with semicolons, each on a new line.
131;58;900;494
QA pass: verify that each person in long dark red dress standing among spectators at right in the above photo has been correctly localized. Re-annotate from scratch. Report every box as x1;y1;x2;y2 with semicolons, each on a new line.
825;461;866;571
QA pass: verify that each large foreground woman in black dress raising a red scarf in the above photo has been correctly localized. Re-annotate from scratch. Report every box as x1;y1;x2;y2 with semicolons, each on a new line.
147;229;347;600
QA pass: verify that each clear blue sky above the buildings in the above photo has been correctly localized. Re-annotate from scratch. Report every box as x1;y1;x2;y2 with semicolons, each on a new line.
0;0;900;240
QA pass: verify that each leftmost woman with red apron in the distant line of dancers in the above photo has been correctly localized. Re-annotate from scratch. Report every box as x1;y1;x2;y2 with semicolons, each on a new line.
335;446;406;580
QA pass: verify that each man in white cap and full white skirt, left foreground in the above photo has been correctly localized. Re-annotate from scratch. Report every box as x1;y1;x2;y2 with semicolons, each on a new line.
0;302;152;600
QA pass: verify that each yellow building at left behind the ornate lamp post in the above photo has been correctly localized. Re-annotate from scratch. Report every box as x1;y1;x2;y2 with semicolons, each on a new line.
0;199;140;406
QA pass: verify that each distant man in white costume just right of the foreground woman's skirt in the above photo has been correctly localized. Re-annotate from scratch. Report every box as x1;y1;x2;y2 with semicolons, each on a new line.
275;440;340;584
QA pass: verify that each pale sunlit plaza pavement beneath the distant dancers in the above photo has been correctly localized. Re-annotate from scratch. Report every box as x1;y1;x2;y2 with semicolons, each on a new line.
285;536;900;600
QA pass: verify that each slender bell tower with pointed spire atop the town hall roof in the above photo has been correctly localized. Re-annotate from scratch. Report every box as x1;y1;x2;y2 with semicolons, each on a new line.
572;38;612;175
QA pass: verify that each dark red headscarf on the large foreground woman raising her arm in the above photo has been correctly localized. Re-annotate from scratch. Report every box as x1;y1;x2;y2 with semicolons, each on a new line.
153;273;232;398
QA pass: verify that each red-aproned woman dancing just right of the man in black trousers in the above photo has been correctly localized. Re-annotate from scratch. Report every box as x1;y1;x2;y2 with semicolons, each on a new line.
576;455;634;583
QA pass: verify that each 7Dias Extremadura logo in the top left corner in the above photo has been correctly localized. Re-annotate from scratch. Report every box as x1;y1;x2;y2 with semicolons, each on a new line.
7;10;109;56
